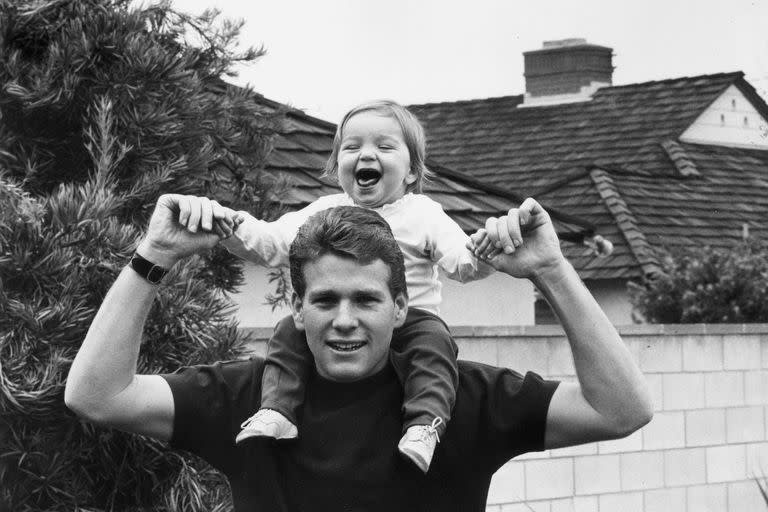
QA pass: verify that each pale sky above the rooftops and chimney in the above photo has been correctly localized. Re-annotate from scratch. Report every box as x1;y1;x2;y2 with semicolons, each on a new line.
174;0;768;122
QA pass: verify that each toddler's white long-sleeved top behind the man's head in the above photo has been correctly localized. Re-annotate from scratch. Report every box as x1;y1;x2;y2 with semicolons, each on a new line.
223;194;494;314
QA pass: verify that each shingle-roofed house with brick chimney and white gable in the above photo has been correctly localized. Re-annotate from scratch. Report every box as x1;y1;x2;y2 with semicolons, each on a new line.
410;39;768;324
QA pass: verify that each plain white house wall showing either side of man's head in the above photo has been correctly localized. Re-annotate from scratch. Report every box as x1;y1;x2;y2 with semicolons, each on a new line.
232;263;534;327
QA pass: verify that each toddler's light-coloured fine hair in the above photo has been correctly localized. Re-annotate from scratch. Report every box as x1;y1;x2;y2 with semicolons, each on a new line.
323;100;432;194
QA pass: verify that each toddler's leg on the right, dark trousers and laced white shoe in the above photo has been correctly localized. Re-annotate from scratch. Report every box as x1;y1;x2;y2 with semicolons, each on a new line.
390;308;459;472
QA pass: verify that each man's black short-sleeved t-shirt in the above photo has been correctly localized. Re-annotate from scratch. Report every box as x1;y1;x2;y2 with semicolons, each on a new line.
164;358;557;512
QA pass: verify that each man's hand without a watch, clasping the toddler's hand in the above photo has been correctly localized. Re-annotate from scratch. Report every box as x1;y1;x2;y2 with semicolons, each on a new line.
470;197;565;279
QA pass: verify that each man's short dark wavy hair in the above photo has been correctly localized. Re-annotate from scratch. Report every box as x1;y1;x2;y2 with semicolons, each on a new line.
289;206;408;299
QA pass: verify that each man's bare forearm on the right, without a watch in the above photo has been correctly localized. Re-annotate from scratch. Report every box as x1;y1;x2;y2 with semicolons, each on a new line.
534;260;652;432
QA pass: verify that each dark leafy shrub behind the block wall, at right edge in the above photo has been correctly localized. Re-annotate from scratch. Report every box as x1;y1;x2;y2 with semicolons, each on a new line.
630;240;768;323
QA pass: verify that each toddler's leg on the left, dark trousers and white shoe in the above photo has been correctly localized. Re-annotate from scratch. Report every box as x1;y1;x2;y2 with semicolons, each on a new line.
235;315;312;443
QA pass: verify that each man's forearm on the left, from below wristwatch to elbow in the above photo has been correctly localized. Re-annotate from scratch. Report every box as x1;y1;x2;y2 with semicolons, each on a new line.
64;267;157;419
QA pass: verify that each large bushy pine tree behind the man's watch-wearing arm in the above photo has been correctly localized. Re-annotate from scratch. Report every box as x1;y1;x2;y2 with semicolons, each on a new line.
0;0;280;511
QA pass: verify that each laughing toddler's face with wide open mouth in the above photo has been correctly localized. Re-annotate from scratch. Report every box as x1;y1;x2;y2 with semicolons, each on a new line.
338;111;416;208
